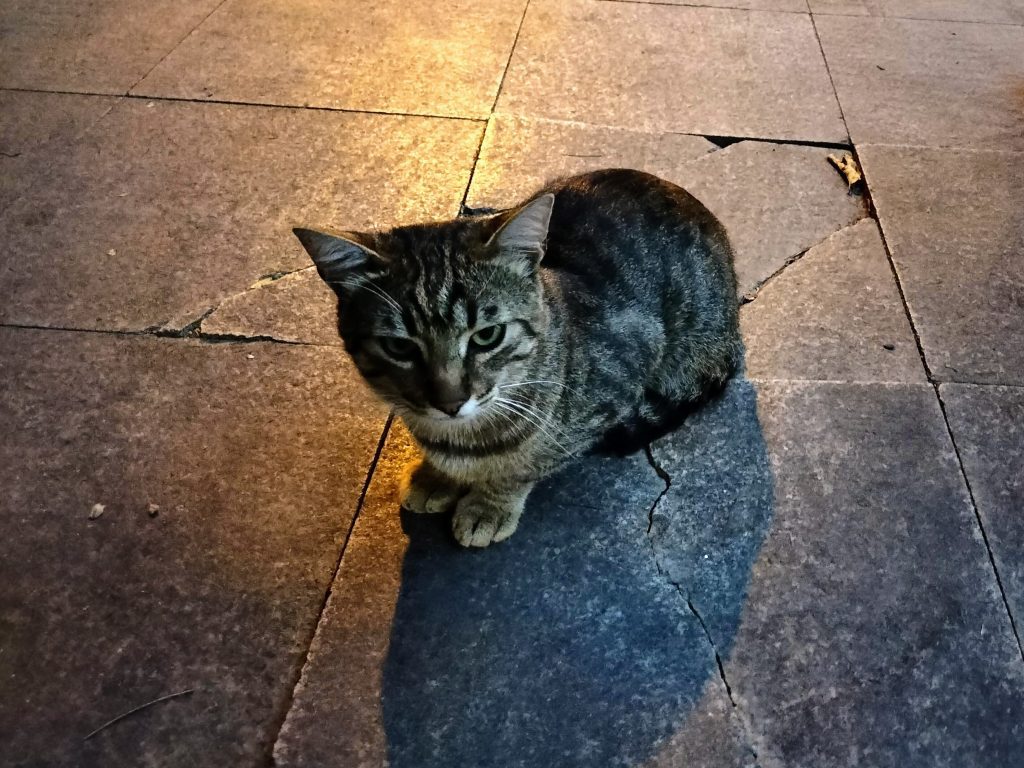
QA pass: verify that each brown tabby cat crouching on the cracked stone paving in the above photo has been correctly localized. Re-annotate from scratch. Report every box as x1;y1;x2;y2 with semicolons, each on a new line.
294;169;741;547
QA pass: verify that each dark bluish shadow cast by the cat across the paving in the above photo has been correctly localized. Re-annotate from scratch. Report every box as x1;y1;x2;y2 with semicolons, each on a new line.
382;382;772;768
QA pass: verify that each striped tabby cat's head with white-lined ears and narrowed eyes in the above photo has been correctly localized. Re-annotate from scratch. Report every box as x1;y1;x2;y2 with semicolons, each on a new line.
295;195;554;432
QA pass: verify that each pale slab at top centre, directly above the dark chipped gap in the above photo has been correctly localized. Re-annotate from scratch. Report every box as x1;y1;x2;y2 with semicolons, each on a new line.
498;0;847;141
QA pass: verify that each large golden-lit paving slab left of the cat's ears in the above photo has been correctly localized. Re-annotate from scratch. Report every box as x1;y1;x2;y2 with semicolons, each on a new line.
0;99;482;330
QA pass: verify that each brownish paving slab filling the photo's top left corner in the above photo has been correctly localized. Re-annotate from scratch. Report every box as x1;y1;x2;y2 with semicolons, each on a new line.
0;0;221;93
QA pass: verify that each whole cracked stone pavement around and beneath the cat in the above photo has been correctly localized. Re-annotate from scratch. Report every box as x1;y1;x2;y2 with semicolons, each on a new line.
0;0;1024;768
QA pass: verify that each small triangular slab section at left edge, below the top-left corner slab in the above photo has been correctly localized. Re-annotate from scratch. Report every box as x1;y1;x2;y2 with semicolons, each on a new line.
0;90;117;211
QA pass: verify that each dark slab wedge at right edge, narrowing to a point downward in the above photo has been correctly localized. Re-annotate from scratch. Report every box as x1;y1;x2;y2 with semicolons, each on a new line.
939;384;1024;632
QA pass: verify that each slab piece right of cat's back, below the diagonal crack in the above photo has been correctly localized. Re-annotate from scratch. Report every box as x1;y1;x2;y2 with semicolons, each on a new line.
739;219;926;382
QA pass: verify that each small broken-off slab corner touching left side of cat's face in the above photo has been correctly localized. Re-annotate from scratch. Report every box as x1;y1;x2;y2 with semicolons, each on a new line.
200;267;341;345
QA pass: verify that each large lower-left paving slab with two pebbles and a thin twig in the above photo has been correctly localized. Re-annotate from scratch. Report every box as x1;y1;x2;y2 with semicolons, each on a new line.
0;329;385;768
